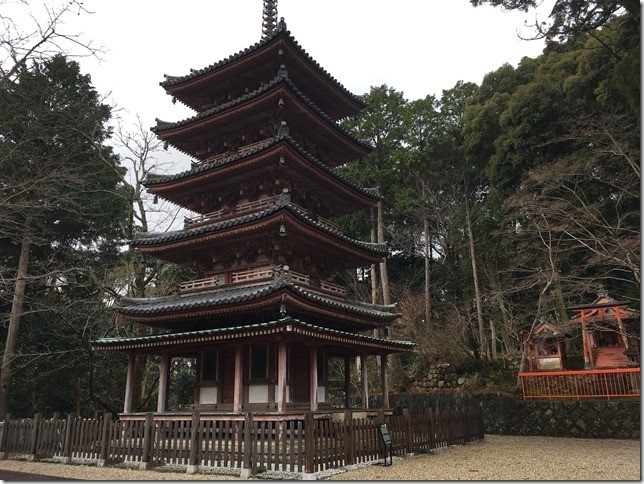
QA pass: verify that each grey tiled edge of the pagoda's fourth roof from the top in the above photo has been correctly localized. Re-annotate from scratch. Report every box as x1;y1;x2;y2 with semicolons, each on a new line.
132;197;387;256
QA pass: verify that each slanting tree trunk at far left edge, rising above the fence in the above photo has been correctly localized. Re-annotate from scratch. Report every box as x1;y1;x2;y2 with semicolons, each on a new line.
0;218;31;420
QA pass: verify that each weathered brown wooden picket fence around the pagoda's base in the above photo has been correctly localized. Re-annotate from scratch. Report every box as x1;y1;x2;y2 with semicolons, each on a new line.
0;409;484;476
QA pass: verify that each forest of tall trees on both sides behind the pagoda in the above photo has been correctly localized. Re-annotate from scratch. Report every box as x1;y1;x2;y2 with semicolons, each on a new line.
0;0;641;418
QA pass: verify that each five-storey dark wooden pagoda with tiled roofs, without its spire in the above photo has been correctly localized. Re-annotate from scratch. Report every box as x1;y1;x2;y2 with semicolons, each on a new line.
93;19;414;413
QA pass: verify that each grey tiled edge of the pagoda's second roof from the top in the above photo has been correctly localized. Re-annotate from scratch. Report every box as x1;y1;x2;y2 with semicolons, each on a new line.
150;74;372;156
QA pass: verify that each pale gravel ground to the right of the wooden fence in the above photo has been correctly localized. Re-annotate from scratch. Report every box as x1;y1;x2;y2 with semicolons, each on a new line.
330;435;641;481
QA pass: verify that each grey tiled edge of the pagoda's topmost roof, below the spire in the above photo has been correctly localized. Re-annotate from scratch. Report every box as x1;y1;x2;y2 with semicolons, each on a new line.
159;22;365;107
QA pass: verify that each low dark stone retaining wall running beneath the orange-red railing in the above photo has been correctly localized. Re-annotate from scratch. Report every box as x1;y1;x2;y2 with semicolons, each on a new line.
373;393;640;439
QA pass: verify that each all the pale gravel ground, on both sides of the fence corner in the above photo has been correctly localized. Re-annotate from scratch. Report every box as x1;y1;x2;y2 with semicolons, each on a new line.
0;435;641;481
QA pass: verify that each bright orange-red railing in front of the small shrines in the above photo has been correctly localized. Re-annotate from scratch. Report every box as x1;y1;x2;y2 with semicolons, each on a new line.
519;368;640;400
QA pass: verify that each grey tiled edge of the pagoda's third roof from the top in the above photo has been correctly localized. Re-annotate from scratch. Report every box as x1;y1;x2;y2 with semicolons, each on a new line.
143;135;382;200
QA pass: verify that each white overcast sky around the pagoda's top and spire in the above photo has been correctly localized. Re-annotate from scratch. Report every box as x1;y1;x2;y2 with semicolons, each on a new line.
60;0;552;130
